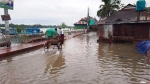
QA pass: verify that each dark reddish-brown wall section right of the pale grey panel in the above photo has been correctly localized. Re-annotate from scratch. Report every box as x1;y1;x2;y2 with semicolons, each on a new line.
113;23;150;41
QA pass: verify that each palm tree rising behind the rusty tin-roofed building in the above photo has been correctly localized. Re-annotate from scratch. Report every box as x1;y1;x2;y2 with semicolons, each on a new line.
97;0;123;17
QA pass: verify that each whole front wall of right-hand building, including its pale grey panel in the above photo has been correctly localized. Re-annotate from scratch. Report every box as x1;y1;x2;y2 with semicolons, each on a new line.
98;23;150;42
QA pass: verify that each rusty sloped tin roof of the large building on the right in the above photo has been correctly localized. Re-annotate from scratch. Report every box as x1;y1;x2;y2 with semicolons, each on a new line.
98;4;150;24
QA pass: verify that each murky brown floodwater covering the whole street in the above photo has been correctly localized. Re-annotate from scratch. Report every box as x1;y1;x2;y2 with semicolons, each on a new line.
0;33;150;84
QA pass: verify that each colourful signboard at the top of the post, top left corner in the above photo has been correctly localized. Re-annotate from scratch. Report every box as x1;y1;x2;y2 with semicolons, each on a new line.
0;0;14;10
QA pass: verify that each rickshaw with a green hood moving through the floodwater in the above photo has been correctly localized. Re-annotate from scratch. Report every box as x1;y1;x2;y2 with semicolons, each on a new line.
43;29;64;52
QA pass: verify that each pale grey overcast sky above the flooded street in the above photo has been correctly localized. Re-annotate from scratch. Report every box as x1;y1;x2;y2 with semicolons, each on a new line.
0;0;150;26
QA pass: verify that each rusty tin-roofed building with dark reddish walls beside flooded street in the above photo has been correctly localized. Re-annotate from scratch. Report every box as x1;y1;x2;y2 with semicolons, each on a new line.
96;4;150;43
